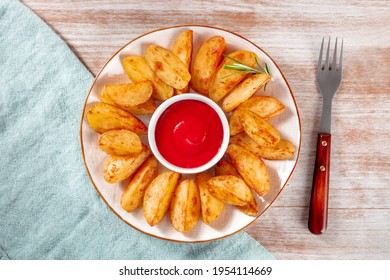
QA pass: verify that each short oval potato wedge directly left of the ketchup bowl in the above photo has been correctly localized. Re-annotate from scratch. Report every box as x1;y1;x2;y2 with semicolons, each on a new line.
98;129;142;156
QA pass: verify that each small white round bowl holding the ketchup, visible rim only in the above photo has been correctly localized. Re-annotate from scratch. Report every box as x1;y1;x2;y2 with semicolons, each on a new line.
148;93;230;174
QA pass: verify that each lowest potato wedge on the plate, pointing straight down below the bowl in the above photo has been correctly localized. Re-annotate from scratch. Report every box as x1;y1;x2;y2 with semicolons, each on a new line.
170;179;200;232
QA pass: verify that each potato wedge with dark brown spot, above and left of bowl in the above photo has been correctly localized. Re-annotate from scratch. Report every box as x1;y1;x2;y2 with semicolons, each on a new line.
145;44;191;89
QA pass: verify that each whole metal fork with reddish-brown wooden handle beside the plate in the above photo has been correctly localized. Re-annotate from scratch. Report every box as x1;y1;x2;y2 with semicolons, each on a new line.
309;37;344;234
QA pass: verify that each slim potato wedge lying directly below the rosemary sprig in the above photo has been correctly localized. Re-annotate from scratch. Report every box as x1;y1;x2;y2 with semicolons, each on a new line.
222;73;271;113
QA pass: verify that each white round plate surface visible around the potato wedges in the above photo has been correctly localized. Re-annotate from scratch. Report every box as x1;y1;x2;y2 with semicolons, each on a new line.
80;25;301;242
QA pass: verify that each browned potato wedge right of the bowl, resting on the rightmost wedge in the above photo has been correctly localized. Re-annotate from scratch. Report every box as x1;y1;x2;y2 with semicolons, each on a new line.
239;109;280;147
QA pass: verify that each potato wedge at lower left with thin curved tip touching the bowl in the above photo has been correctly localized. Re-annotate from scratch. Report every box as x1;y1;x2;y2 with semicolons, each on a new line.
103;145;150;183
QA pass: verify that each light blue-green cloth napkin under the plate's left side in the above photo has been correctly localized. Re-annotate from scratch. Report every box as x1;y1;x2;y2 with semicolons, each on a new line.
0;0;273;260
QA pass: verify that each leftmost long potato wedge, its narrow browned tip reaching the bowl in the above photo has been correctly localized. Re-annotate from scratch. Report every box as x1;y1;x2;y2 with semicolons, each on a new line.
87;103;148;135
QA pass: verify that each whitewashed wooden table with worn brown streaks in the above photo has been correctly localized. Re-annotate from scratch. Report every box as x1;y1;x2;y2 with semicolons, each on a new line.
24;0;390;259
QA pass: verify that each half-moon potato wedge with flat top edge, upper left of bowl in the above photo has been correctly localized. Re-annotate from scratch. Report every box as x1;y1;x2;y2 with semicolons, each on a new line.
103;81;153;107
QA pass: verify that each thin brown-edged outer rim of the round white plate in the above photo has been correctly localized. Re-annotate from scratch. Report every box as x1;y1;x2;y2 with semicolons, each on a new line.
79;24;302;244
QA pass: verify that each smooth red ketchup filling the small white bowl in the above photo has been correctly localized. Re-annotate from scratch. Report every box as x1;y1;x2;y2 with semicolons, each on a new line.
155;100;223;168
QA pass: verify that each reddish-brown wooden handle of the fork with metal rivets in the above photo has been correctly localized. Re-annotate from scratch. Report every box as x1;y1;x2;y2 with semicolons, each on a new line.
309;133;331;234
